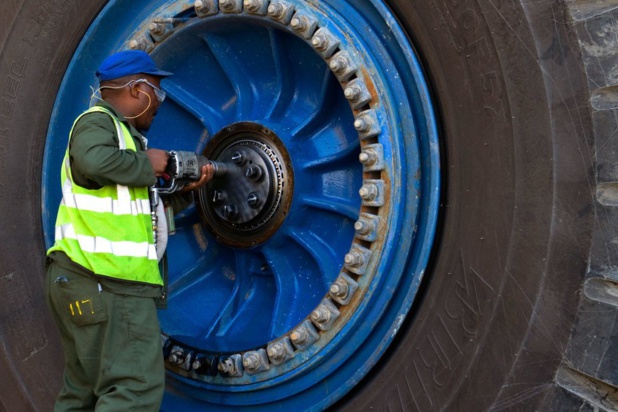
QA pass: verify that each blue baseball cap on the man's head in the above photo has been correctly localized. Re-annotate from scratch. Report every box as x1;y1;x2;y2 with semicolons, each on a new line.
96;50;172;82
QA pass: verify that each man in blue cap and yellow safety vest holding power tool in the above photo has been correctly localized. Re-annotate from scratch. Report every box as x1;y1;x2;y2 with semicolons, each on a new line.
46;50;214;411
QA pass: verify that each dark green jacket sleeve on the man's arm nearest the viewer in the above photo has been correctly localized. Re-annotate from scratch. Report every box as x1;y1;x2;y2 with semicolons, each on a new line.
69;113;156;189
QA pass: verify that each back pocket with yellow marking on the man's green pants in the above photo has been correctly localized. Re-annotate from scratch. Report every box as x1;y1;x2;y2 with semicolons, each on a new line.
52;274;107;326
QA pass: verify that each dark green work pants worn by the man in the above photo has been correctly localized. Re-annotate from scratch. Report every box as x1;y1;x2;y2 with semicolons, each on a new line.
46;262;165;412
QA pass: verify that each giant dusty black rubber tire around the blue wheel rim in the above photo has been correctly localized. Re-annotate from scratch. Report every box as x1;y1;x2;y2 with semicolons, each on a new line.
0;0;618;410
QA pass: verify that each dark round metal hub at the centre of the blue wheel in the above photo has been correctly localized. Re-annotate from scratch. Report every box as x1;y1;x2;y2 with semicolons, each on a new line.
198;122;294;248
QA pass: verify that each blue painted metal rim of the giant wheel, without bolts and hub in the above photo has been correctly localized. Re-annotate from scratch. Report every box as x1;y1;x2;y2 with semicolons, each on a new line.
43;0;440;410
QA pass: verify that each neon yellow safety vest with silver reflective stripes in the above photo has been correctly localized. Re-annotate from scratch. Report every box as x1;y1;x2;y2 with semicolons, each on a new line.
48;106;163;285
